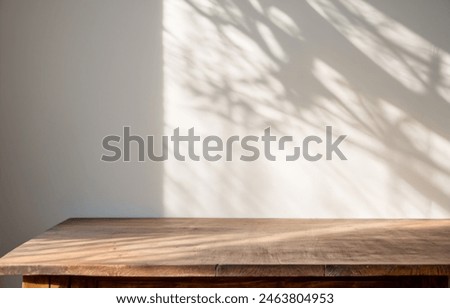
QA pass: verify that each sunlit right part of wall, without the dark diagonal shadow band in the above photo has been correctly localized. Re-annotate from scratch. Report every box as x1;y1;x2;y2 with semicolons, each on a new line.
163;0;450;218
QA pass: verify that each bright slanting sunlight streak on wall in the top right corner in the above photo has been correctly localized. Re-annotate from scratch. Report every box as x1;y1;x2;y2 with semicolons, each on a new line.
308;0;448;93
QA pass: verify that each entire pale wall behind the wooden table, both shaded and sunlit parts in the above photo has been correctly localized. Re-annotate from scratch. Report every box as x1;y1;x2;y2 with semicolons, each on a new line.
0;0;450;285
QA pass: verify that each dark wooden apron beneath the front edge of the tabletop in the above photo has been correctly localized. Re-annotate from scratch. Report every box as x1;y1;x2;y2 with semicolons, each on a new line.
24;276;448;288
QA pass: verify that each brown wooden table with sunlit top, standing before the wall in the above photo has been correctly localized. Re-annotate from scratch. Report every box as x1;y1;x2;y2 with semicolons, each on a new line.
0;218;450;288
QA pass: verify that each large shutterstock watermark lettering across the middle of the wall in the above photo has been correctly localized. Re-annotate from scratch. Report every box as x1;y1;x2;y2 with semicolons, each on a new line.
101;126;347;162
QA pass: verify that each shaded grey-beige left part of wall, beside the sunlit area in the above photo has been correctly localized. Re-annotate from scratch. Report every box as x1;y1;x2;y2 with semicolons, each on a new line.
0;0;163;288
